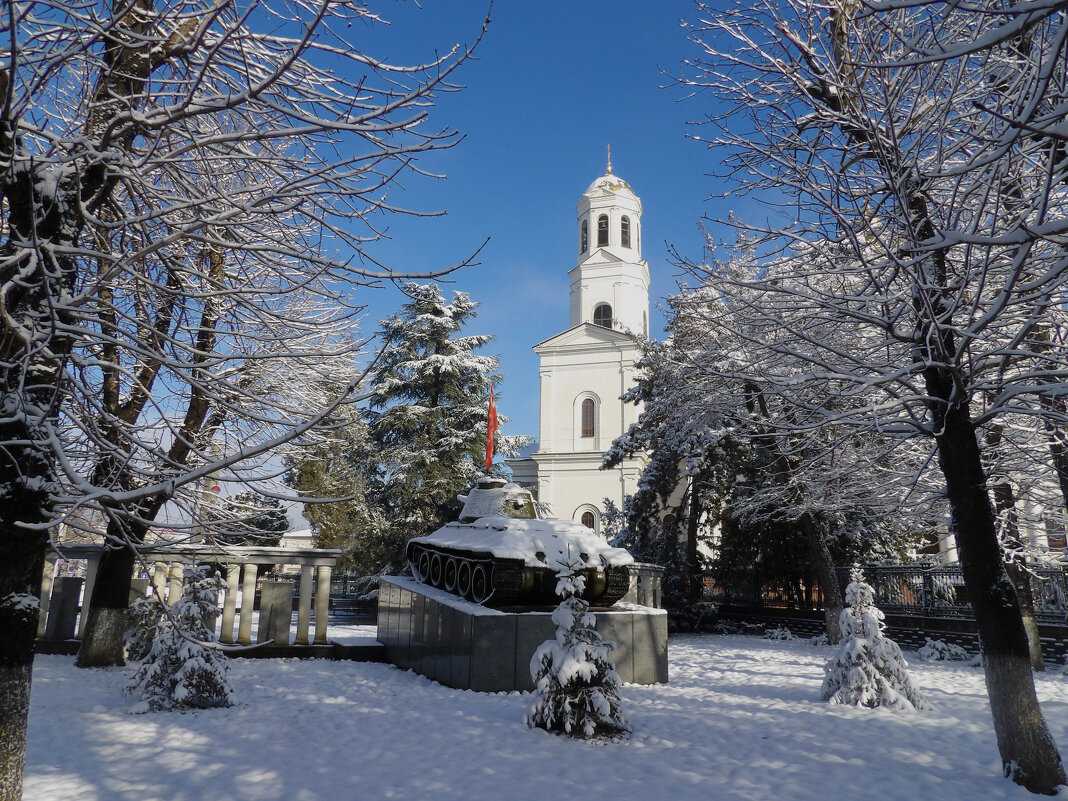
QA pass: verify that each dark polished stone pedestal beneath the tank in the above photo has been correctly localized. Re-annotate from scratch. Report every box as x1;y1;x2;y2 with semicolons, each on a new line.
378;576;668;692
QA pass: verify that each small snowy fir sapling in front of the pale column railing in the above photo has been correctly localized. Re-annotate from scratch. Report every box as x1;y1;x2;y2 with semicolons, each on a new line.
125;566;234;712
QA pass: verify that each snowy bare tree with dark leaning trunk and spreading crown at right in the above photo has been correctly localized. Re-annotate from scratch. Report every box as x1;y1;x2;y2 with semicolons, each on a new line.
687;0;1068;792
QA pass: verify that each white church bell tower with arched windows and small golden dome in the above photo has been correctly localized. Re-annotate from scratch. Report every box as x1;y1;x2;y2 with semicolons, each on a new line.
508;158;649;531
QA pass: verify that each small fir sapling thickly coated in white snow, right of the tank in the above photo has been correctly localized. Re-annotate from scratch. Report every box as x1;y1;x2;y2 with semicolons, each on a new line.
822;567;930;709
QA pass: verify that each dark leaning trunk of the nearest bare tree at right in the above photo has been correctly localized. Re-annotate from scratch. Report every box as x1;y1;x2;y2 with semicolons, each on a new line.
927;407;1066;795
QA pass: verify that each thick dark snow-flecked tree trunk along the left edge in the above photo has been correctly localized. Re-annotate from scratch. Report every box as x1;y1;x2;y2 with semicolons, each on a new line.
0;9;198;801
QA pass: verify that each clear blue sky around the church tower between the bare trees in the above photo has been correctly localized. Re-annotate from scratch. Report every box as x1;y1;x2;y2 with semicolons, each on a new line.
354;0;747;436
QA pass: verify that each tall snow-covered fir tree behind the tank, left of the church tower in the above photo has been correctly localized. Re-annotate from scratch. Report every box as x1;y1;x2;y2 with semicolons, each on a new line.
360;283;505;572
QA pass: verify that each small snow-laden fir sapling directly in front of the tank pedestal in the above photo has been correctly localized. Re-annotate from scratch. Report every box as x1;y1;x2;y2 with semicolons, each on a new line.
523;563;630;738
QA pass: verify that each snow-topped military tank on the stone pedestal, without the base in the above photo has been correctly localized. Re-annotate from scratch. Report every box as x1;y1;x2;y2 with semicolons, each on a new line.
407;476;634;607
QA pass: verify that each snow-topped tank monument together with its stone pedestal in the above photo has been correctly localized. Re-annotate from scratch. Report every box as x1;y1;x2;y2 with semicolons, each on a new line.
378;476;668;692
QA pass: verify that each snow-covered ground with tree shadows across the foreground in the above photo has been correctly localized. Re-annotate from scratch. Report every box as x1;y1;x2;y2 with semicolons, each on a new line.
25;627;1068;801
